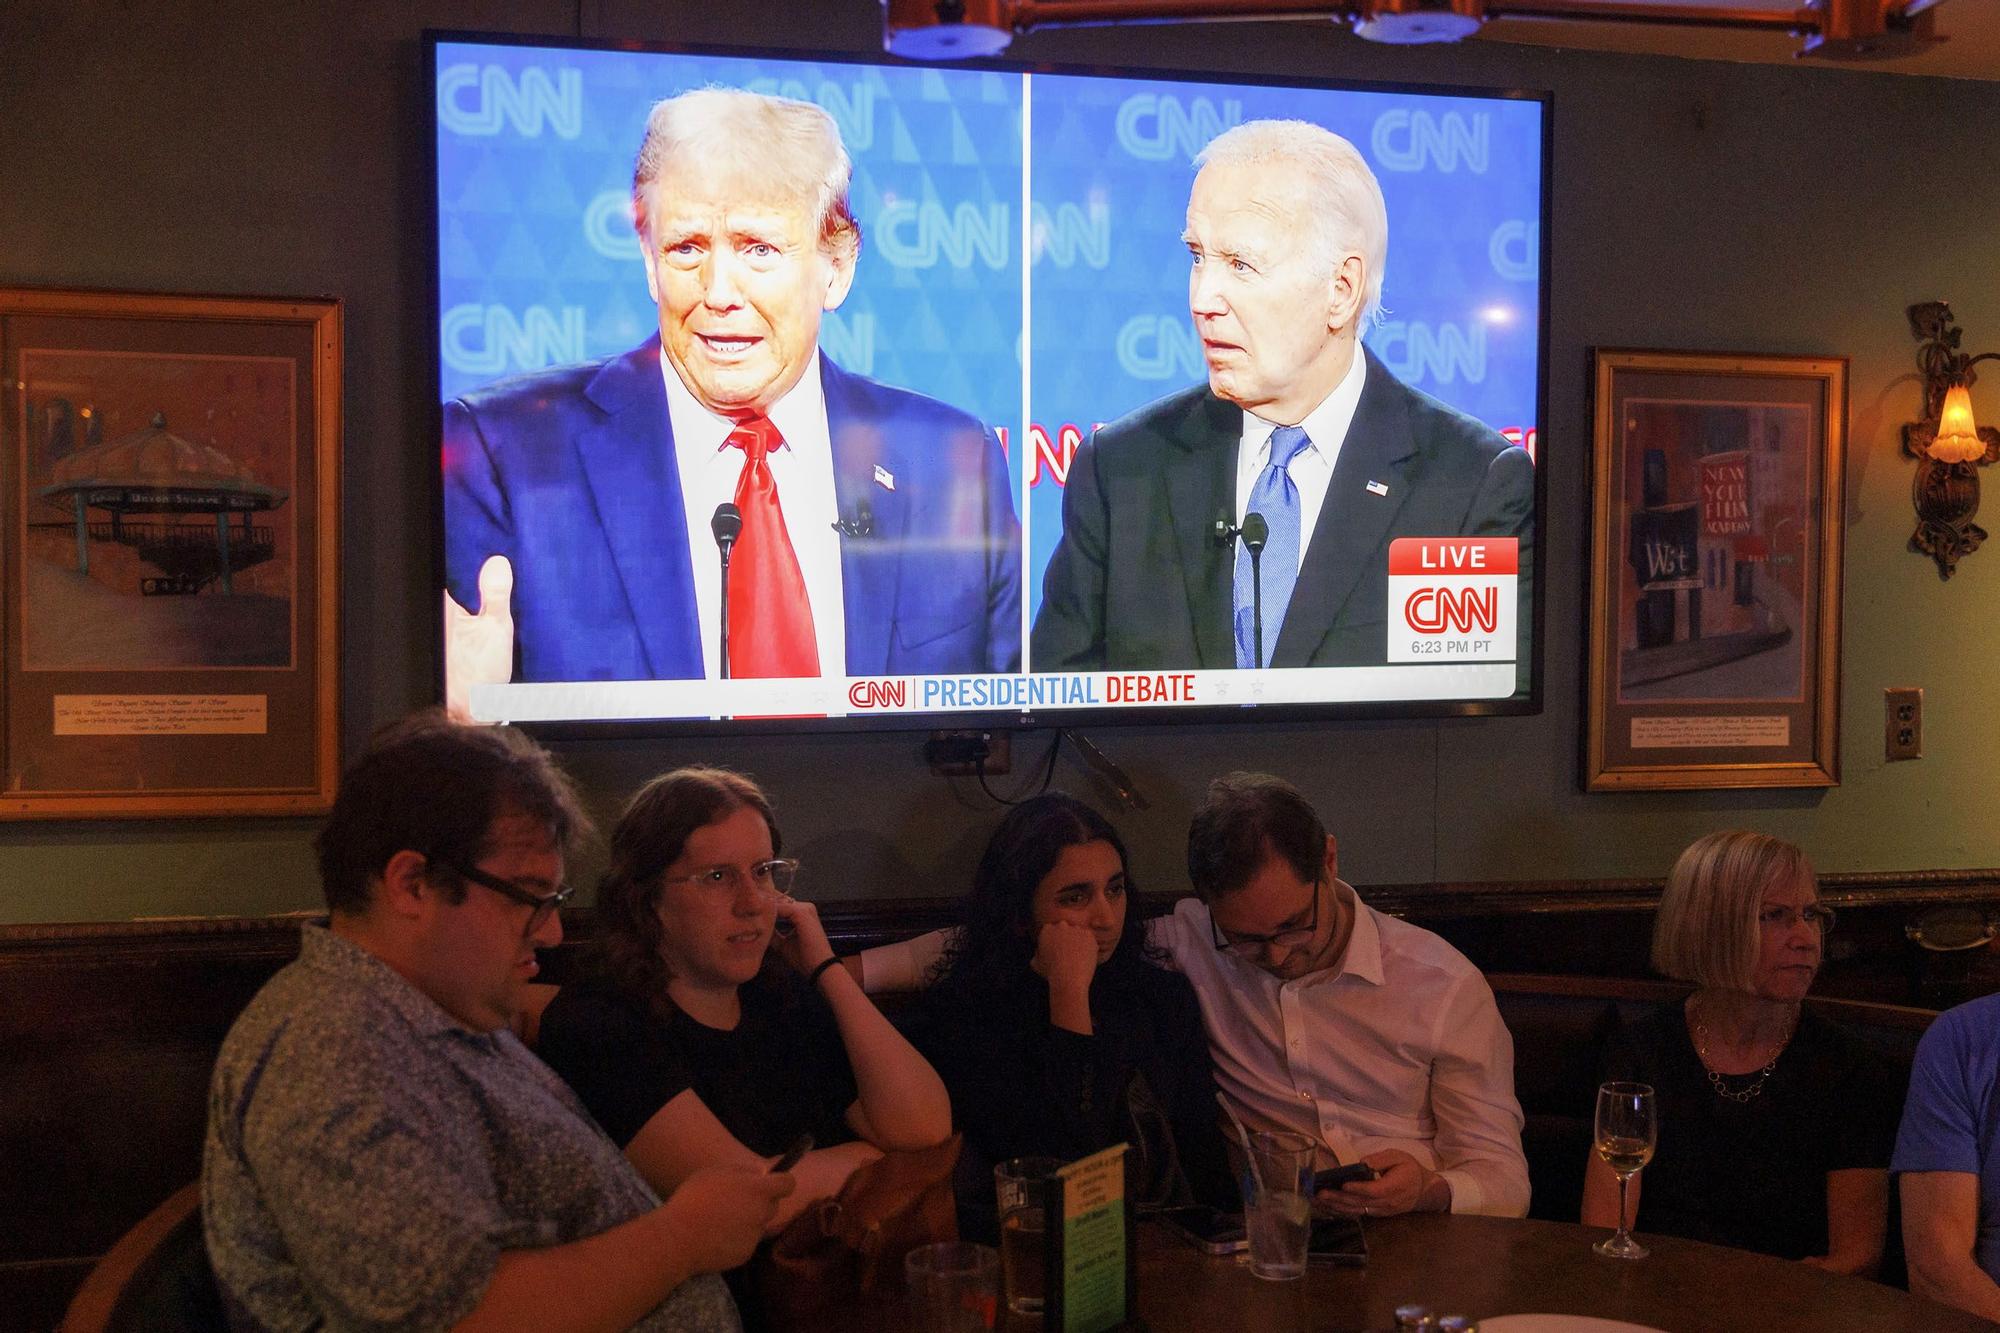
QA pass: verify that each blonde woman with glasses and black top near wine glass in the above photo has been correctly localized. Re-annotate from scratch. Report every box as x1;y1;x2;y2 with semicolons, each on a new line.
1582;833;1902;1275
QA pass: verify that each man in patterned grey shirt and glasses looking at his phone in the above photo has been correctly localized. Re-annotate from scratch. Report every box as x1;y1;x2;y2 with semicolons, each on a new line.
202;713;792;1331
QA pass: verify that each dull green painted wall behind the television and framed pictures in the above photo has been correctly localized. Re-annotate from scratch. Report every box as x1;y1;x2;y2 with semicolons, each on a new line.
0;0;2000;923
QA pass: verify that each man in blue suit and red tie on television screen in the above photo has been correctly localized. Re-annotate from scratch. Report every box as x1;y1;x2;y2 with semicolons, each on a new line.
444;88;1020;709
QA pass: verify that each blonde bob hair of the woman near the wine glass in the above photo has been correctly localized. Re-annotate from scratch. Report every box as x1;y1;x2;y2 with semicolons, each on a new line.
1652;829;1818;991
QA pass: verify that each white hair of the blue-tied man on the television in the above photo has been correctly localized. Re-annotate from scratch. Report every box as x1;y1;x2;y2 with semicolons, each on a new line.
1194;120;1388;320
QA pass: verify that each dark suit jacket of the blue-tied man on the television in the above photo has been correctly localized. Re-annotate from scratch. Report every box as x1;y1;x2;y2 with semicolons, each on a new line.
1030;350;1534;671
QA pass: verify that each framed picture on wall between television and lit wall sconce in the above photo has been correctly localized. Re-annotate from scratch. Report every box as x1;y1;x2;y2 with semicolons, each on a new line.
1584;350;1848;791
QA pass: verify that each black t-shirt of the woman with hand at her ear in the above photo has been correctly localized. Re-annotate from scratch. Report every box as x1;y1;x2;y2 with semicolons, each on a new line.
536;965;856;1157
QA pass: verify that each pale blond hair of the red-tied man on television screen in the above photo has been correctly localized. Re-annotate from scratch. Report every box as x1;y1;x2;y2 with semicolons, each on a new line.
632;88;862;254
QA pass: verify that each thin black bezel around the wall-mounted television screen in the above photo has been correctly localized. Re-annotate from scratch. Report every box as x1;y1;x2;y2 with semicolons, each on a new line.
420;28;1556;739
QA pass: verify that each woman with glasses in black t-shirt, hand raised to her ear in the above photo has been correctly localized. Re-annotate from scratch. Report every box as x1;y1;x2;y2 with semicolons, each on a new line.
538;769;952;1229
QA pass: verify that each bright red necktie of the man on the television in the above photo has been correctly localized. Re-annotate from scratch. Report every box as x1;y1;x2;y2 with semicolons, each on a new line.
724;414;820;679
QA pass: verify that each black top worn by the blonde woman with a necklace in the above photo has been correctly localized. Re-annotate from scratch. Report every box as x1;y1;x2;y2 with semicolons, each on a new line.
1604;1005;1904;1259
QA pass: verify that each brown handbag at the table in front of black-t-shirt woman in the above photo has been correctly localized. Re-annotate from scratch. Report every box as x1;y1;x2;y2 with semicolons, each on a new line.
752;1135;962;1329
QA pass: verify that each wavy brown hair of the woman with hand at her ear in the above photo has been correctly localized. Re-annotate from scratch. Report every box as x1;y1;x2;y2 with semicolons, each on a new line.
596;767;780;1019
